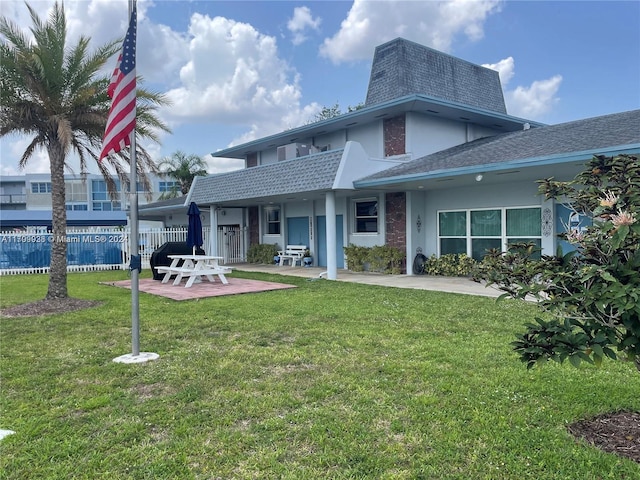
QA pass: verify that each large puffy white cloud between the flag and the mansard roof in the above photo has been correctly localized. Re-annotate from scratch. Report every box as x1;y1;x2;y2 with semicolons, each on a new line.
163;13;320;140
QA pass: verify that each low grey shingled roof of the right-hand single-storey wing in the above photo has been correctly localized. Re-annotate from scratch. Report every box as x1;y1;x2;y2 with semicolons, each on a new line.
354;110;640;187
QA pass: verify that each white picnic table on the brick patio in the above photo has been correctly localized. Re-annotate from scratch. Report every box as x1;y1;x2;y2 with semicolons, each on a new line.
155;255;231;288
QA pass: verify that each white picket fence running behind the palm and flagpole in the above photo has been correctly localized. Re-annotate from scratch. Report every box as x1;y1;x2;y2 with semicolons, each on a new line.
0;227;246;275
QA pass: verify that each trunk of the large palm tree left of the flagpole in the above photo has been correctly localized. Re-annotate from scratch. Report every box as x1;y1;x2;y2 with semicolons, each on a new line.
47;141;68;298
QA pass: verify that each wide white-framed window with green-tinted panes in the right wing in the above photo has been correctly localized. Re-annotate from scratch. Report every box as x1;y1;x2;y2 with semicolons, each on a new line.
438;207;542;260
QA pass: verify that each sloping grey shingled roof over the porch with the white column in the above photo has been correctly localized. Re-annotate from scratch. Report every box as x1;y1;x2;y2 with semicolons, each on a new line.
190;149;344;204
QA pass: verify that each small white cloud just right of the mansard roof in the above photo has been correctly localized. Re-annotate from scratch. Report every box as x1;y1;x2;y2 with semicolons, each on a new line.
505;75;562;119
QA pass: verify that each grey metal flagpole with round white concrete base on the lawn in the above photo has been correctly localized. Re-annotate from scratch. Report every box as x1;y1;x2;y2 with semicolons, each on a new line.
113;0;159;363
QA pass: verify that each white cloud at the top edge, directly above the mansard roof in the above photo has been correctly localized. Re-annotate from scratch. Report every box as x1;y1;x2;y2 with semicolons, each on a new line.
320;0;501;64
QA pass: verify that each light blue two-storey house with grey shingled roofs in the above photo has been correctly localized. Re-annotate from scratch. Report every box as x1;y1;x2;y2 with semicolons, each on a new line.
139;38;640;279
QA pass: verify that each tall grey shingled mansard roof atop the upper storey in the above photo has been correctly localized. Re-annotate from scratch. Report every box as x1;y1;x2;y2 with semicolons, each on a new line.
365;38;507;114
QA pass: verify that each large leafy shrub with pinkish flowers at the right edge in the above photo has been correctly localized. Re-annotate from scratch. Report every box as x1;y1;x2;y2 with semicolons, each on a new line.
477;155;640;370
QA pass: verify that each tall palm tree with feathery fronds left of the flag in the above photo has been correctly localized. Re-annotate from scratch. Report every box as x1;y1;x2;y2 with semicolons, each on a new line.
0;2;169;299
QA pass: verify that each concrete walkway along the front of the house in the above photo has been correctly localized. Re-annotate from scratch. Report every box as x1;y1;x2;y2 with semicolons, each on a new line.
232;263;503;297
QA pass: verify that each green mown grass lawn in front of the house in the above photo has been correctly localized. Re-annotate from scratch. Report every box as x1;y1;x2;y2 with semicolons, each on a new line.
0;271;640;480
